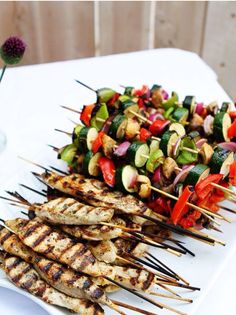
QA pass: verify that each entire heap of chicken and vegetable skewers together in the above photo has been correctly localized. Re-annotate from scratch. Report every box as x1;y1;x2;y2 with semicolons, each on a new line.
0;82;236;315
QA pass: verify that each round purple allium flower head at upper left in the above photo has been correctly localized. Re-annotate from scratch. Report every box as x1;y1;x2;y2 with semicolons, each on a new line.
0;36;26;65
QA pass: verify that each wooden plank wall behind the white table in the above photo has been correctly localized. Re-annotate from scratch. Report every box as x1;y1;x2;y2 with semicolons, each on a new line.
0;1;236;98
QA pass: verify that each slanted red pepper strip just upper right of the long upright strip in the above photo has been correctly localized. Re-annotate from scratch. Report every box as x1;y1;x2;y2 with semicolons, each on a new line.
195;174;223;200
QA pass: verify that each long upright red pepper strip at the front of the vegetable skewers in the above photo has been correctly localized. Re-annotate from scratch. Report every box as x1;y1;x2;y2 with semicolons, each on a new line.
171;185;193;225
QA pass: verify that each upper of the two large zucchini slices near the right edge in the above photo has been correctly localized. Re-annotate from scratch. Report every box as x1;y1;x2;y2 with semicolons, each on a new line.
213;112;231;142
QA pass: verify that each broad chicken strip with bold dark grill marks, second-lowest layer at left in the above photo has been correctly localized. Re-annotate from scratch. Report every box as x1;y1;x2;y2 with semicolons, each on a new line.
5;218;114;277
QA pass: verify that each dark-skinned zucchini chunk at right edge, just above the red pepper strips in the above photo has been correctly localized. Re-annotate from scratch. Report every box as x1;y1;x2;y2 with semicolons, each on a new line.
209;148;234;177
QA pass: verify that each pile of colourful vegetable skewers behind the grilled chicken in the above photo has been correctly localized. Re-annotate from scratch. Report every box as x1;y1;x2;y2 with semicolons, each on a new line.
53;81;236;229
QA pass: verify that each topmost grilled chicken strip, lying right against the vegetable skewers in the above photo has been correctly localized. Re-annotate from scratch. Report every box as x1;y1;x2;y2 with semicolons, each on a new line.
42;172;149;214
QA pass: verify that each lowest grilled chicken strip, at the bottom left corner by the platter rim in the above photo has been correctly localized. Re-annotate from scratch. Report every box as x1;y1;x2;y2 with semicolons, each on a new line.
0;256;104;315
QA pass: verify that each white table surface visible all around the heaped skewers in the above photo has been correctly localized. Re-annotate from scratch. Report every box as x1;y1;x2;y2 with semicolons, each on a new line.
0;49;236;315
